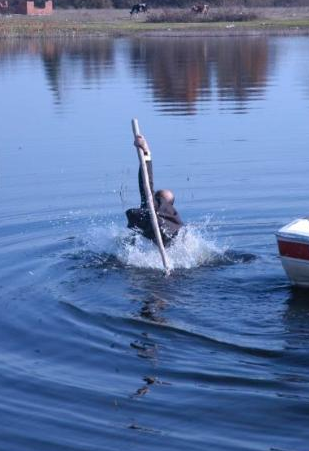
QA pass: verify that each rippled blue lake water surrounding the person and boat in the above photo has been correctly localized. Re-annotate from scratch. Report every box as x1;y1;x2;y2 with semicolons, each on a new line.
0;37;309;451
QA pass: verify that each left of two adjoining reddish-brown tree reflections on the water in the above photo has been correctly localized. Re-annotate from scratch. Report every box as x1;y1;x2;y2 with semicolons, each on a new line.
131;38;210;112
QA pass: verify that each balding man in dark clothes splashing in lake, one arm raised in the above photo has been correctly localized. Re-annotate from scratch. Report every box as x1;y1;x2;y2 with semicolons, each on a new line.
126;136;183;246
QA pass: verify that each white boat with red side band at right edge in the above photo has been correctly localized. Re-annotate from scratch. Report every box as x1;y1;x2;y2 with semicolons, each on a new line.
276;218;309;287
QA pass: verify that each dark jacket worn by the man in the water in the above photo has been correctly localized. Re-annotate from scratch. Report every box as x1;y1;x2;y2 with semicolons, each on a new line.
126;161;183;246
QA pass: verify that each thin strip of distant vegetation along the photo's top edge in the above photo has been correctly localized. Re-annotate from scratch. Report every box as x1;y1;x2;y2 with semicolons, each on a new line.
54;0;309;9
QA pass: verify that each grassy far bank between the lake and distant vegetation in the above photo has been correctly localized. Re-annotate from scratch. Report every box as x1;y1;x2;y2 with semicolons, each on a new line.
0;8;309;38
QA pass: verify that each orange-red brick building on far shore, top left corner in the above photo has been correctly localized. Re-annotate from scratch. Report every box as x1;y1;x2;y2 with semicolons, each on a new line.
0;0;53;16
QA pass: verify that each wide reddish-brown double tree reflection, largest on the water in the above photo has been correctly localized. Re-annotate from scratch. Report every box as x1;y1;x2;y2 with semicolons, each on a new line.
131;37;275;114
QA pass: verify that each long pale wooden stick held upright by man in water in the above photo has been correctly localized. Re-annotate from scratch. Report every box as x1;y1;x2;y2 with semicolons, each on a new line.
132;119;170;274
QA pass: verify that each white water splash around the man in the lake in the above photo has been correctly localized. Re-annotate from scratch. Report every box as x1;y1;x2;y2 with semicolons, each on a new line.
85;220;227;269
